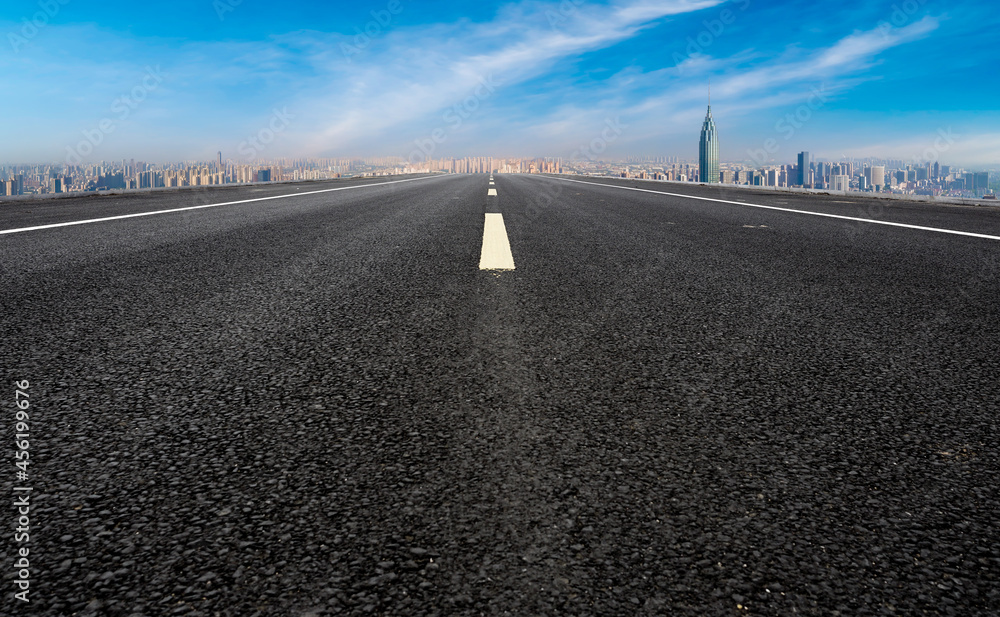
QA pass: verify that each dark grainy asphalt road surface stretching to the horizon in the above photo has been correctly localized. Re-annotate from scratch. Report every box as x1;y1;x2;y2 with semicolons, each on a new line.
0;175;1000;617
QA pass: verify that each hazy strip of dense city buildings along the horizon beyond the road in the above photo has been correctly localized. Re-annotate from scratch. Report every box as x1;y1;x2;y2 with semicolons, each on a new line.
0;152;1000;198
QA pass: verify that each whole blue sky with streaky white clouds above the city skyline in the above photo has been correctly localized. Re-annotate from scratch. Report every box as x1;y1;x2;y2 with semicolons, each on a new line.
0;0;1000;165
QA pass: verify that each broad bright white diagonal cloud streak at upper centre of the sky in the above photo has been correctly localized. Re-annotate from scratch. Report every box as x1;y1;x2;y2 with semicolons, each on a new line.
288;0;722;154
